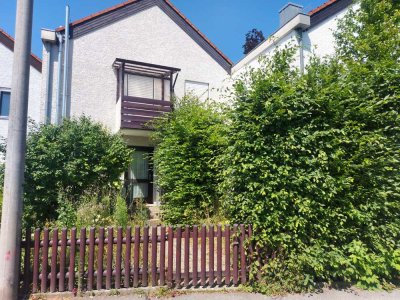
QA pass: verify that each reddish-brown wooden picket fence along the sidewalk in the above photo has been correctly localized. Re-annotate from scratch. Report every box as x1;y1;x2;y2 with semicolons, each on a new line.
21;225;251;293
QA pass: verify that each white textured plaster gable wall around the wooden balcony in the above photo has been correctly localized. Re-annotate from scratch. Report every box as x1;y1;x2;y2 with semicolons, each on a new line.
43;6;228;131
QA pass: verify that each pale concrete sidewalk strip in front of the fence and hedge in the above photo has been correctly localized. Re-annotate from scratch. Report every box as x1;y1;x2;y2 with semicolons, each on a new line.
31;288;400;300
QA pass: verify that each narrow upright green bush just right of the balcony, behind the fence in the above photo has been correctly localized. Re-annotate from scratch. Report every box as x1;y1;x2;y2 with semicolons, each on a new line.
153;97;225;224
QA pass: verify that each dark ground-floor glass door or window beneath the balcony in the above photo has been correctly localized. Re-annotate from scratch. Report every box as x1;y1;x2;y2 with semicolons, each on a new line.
125;147;153;204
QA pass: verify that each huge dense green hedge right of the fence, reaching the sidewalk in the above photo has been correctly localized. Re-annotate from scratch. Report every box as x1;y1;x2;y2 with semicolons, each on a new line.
223;0;400;292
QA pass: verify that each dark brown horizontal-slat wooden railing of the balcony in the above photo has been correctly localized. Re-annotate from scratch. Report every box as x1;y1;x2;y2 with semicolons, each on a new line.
121;96;172;129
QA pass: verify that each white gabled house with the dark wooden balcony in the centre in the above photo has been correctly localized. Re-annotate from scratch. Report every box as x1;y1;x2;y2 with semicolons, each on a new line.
41;0;232;205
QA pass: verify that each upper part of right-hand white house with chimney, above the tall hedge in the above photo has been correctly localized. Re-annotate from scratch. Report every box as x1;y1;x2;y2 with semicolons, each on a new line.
232;0;354;79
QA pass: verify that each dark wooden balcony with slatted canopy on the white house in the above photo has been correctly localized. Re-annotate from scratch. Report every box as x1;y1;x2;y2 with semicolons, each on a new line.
113;58;180;130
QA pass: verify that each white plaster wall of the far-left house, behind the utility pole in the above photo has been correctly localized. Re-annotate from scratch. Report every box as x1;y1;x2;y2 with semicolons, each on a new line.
0;44;42;138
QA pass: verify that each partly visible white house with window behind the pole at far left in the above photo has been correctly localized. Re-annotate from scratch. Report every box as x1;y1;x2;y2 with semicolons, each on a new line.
0;28;42;141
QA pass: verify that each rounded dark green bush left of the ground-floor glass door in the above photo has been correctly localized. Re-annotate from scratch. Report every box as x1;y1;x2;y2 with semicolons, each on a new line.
24;117;132;225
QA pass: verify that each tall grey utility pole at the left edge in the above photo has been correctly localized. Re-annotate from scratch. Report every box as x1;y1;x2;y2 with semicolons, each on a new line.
0;0;33;300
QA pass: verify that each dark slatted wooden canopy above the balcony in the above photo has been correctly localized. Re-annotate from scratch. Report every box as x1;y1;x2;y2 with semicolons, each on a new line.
113;58;181;80
